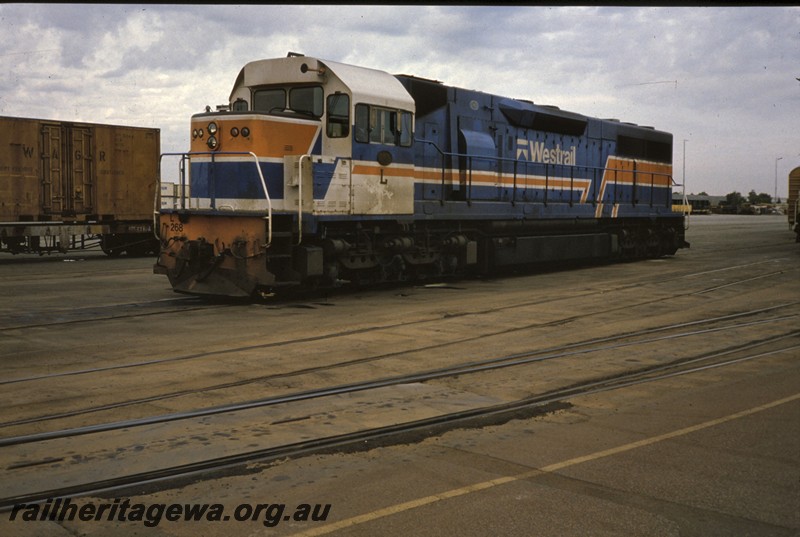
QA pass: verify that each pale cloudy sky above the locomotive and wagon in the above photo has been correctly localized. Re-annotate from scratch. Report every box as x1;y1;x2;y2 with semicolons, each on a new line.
0;3;800;198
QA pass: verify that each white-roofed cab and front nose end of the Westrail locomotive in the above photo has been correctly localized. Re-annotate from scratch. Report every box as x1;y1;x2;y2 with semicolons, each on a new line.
155;54;414;295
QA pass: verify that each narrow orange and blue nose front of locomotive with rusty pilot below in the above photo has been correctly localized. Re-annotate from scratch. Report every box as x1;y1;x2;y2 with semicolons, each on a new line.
154;114;274;296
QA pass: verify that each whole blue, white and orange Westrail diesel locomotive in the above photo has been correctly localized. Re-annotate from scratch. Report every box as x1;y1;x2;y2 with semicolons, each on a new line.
154;53;688;296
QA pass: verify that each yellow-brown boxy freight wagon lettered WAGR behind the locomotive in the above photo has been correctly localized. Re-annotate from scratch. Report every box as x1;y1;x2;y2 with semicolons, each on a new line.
0;117;161;256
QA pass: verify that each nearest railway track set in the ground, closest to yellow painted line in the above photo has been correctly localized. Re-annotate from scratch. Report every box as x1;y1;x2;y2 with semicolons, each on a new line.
0;331;800;511
